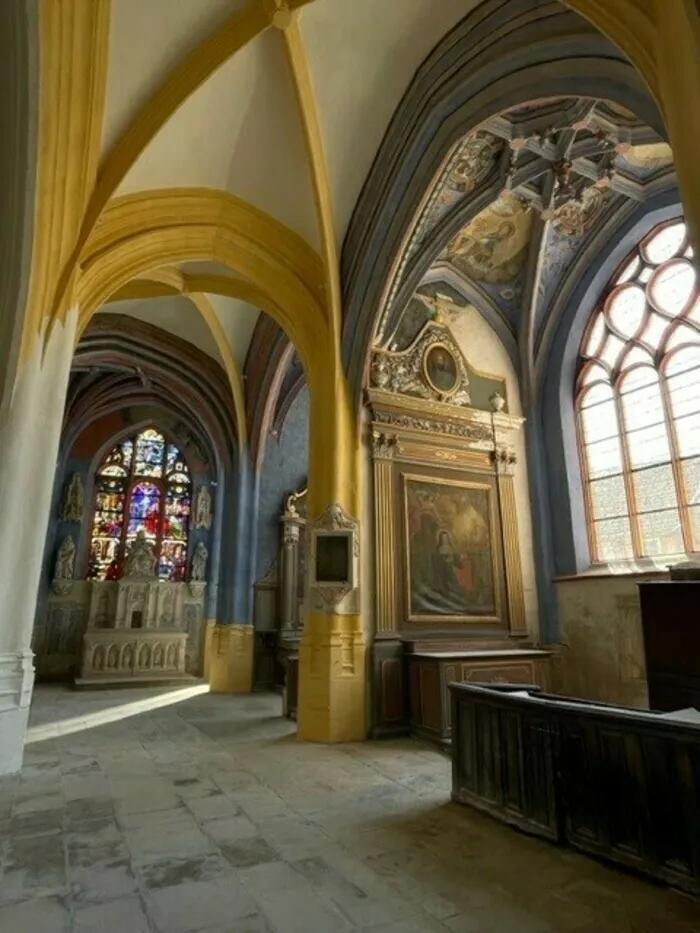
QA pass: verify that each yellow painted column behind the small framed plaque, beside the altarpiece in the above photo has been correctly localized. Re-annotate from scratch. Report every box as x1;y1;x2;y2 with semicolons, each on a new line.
297;359;367;742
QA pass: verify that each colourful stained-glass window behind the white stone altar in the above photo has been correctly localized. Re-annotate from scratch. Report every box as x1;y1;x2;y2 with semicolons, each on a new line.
88;427;192;580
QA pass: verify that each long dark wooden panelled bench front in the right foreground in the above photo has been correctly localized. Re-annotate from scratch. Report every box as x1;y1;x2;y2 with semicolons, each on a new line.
451;684;700;893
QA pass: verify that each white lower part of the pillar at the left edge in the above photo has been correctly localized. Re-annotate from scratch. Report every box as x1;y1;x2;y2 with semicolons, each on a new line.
0;310;78;775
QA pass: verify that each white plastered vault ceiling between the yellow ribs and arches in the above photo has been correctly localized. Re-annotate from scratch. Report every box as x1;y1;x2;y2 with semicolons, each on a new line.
102;0;478;366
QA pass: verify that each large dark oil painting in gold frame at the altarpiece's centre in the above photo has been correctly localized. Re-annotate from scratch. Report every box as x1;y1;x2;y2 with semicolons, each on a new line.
404;476;498;621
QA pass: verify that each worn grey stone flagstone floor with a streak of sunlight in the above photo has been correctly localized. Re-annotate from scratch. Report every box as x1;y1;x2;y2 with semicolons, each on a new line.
0;687;700;933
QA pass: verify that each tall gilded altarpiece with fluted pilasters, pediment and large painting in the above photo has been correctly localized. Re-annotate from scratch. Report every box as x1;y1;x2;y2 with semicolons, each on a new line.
366;320;546;738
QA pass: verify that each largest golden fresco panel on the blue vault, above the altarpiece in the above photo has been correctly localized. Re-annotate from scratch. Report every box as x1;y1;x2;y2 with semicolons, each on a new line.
444;194;533;284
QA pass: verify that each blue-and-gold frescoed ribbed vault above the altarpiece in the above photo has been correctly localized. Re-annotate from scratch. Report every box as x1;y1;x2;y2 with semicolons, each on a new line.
377;97;675;368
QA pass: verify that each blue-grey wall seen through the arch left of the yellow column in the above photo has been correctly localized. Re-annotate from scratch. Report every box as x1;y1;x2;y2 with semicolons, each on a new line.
255;387;309;579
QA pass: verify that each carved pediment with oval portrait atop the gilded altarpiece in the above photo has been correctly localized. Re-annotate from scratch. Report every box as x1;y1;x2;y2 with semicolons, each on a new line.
370;320;471;406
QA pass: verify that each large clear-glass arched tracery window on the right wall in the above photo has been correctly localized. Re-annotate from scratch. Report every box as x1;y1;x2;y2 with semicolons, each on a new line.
576;221;700;563
